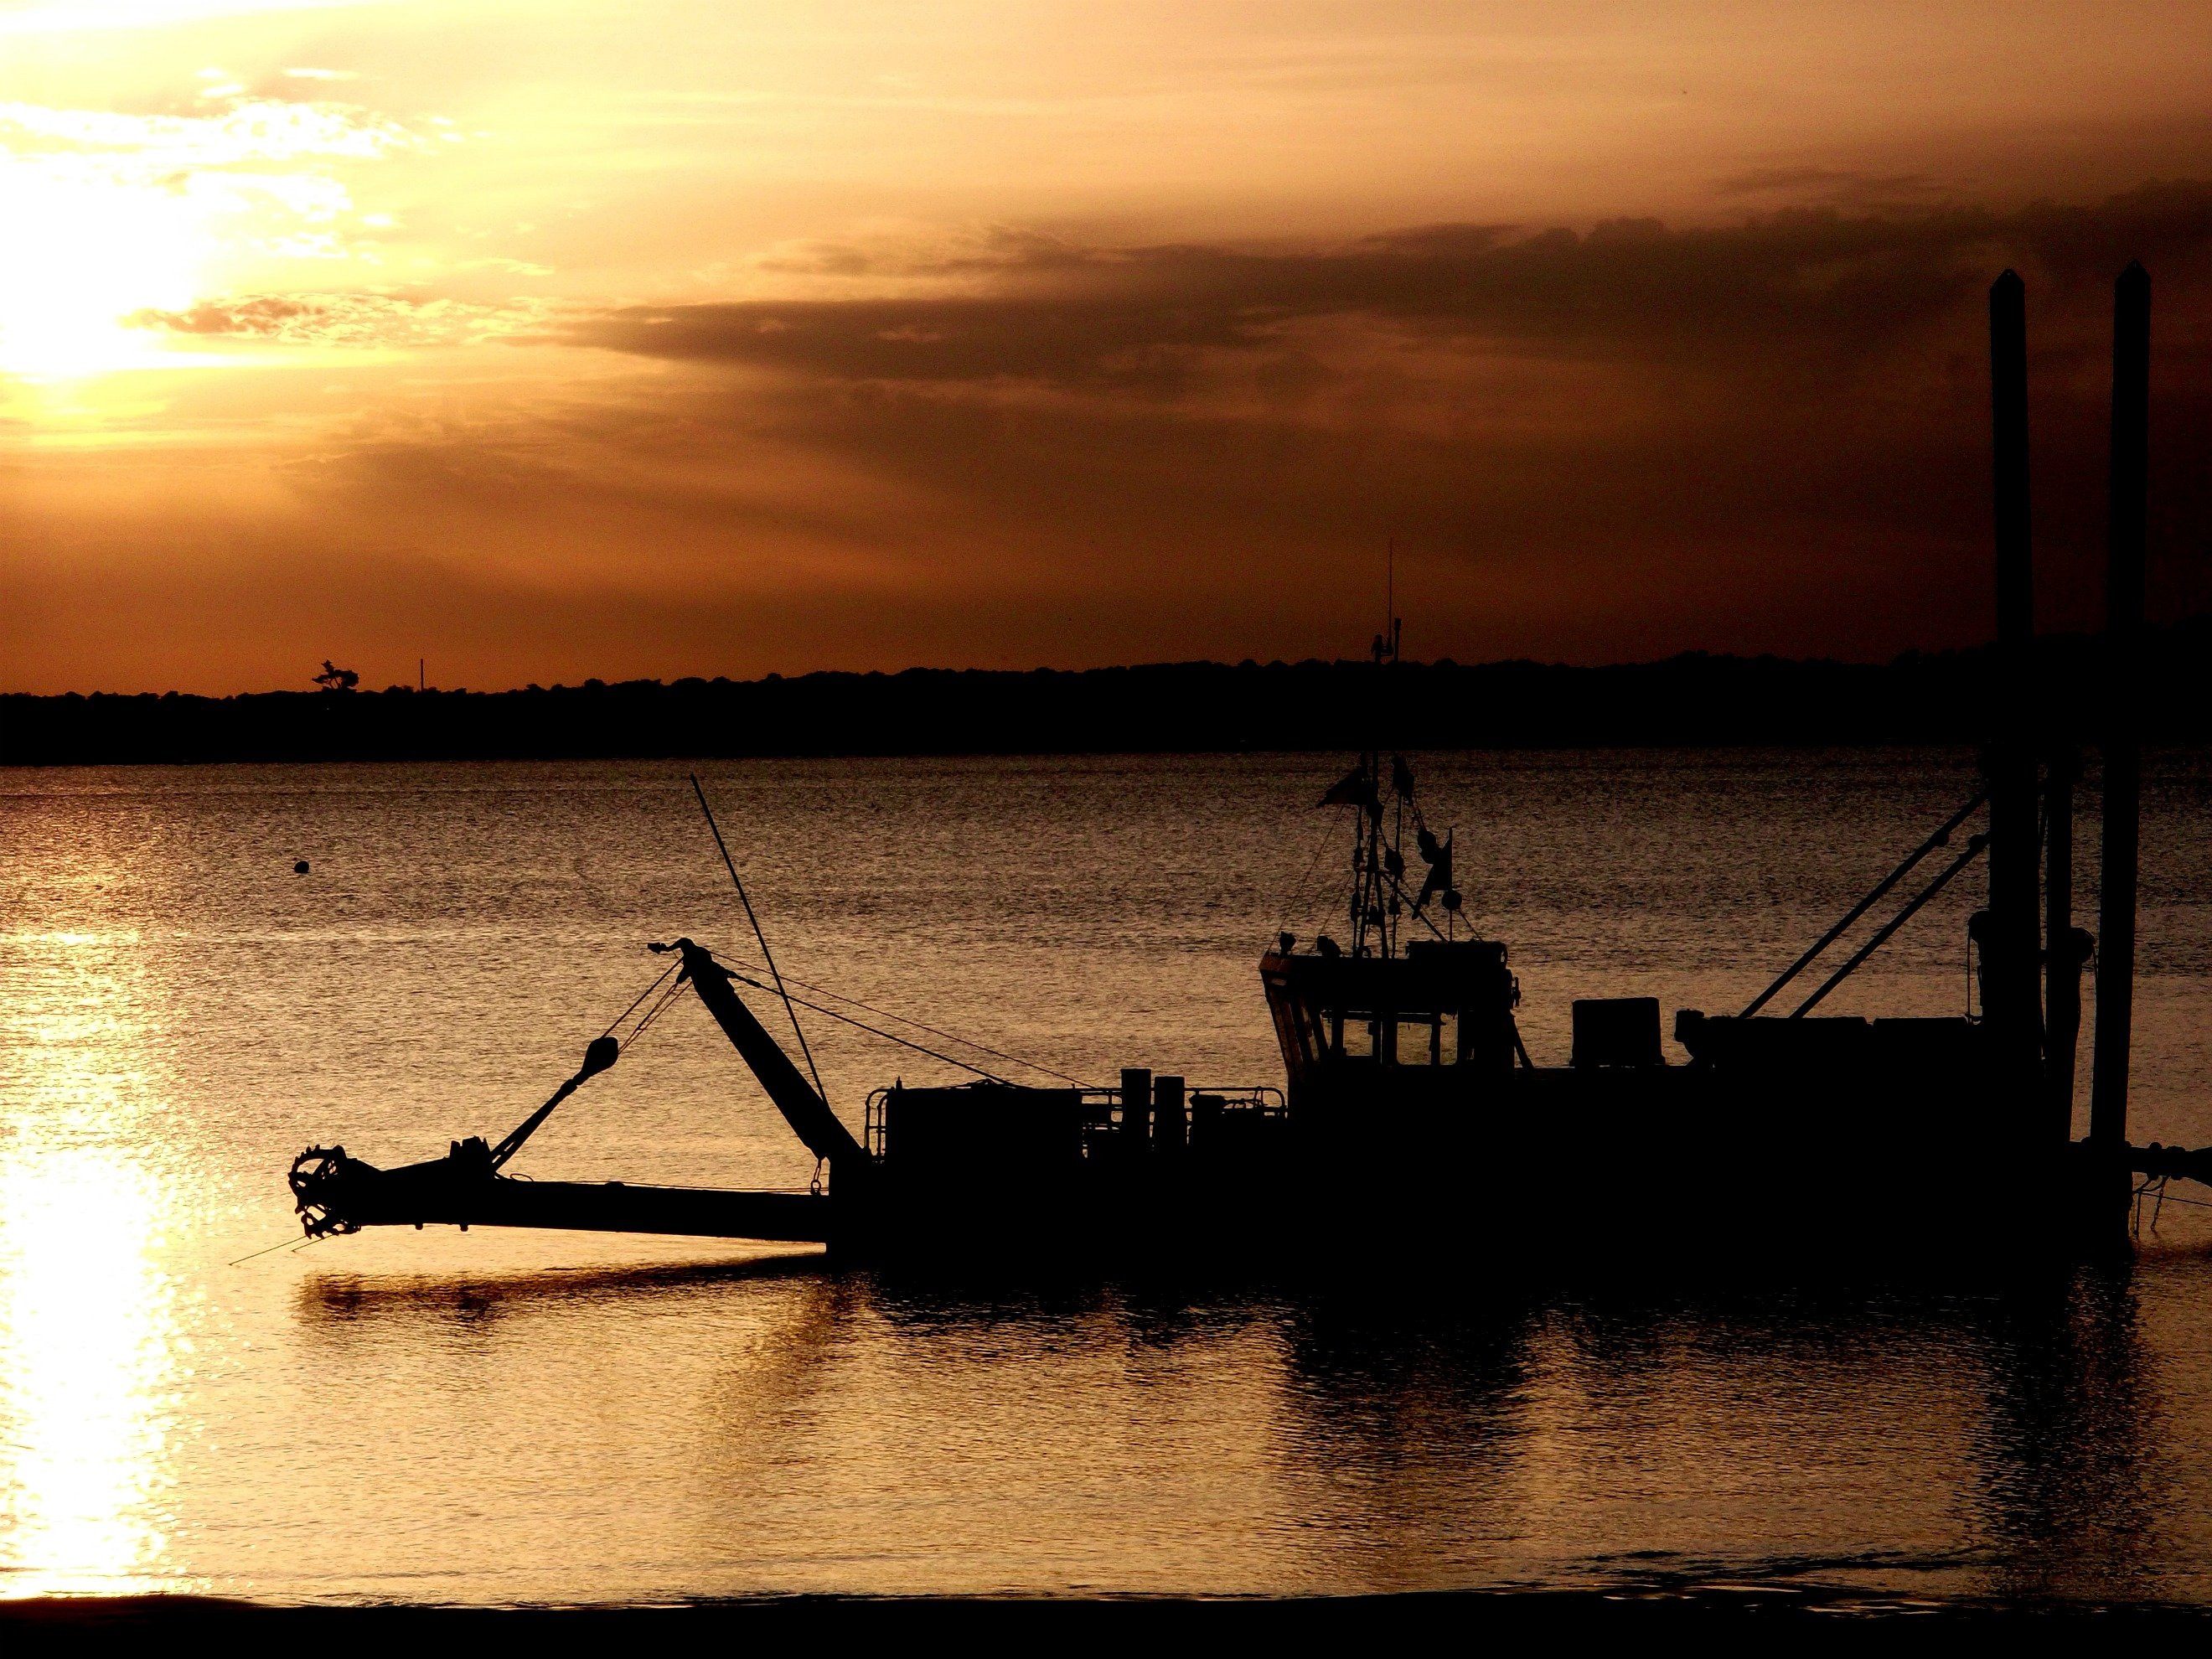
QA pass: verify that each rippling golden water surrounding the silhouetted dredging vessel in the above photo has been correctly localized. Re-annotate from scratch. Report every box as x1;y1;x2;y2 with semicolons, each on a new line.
0;752;2212;1601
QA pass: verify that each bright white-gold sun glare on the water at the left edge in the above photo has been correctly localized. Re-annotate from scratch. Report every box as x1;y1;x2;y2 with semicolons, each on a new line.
0;938;181;1594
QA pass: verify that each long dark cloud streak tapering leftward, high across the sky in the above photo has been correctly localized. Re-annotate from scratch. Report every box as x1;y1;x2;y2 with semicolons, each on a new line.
571;183;2212;385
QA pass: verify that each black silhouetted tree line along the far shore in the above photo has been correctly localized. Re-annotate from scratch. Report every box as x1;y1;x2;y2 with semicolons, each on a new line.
0;618;2212;765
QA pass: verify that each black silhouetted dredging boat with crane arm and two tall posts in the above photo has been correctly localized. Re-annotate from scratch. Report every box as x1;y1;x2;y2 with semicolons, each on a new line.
290;266;2212;1274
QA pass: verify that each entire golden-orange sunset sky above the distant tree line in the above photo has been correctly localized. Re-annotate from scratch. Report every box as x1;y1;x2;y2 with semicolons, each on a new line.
0;0;2212;690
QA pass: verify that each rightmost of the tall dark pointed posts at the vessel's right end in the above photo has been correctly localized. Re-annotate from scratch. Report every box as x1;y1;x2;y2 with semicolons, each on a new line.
2088;263;2150;1150
